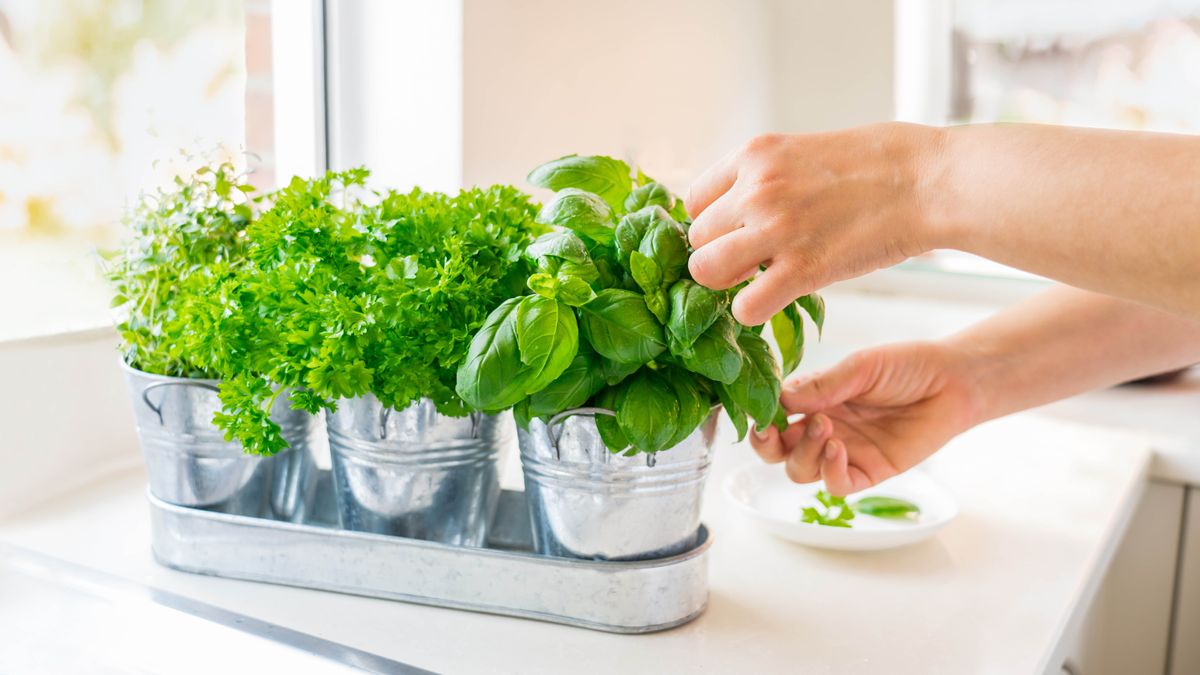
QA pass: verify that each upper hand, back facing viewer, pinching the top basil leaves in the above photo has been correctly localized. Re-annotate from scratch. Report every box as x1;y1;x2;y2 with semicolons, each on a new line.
685;124;942;325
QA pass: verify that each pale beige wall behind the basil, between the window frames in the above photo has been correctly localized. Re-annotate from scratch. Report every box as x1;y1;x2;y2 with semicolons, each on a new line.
462;0;893;191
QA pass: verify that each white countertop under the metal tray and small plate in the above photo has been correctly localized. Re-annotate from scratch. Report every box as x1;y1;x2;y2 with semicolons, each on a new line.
0;416;1151;675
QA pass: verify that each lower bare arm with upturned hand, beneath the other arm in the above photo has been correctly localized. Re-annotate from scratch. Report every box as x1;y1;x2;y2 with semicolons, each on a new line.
751;288;1200;494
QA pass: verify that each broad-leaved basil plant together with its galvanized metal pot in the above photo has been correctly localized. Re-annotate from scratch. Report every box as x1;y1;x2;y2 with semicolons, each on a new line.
457;155;824;560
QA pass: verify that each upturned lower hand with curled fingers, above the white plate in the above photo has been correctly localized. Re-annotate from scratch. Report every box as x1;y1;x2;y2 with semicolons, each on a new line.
750;342;984;495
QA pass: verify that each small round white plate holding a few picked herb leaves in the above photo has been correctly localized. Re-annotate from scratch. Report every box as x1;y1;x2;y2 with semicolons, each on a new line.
725;464;959;551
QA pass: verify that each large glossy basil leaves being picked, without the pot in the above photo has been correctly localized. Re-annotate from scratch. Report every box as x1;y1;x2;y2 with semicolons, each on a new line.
457;155;824;454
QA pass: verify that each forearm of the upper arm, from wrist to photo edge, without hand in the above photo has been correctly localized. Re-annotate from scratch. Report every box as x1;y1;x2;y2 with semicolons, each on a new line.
919;125;1200;318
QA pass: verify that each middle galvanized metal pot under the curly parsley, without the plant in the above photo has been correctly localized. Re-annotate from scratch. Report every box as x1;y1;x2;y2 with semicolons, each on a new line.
326;395;512;546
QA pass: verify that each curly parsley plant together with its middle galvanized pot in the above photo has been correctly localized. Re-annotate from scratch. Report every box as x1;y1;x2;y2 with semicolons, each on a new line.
194;169;544;545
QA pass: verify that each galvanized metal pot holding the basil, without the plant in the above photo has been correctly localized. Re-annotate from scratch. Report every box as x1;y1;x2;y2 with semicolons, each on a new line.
517;408;716;560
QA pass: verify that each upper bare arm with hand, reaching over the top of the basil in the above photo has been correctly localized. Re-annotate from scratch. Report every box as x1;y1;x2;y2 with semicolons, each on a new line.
688;124;1200;324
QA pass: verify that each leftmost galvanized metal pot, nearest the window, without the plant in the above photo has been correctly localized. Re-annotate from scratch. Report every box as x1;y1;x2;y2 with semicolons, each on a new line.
122;363;328;520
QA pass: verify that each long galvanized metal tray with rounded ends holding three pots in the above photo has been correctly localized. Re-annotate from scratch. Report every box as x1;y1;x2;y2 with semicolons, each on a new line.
146;476;710;633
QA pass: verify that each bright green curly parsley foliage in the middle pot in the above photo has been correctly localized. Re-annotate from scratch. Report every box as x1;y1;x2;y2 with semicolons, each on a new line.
111;169;546;454
